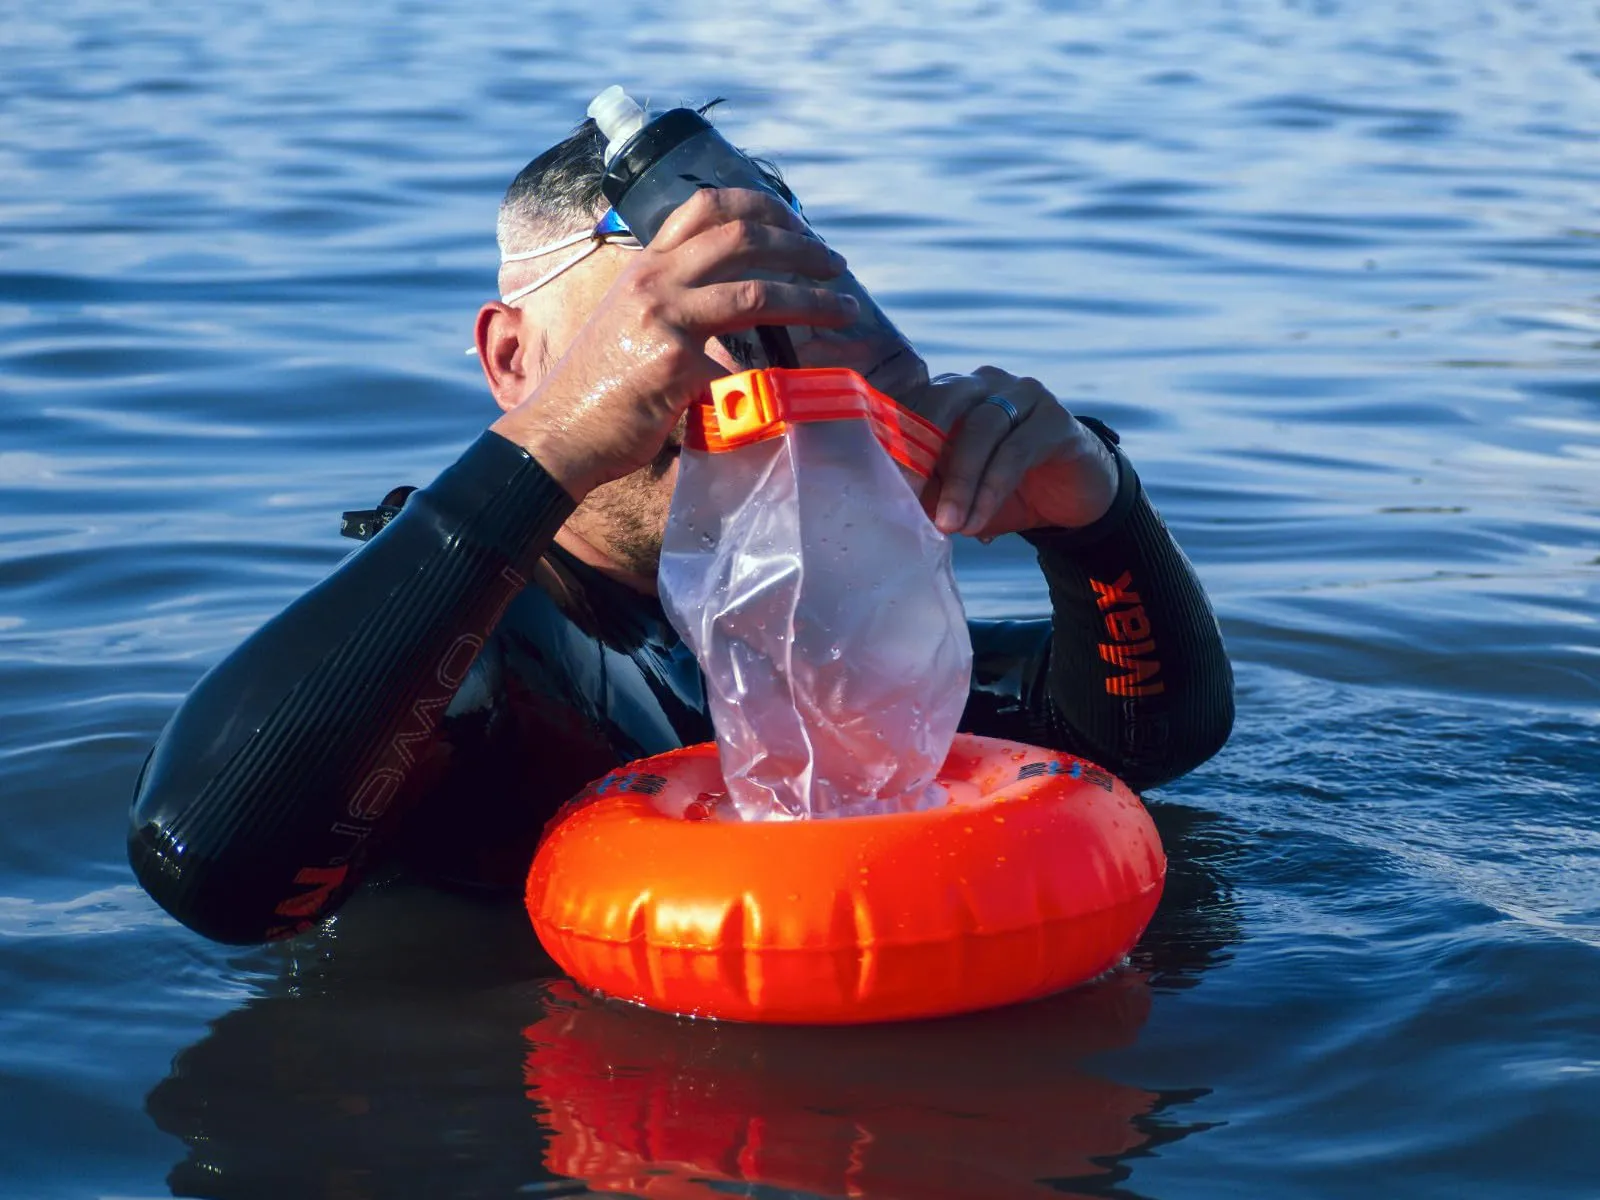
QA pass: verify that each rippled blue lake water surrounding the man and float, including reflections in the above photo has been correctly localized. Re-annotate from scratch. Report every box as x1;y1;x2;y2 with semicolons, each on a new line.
0;0;1600;1200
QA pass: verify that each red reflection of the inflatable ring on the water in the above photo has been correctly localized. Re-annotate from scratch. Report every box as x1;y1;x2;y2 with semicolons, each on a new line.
523;971;1162;1200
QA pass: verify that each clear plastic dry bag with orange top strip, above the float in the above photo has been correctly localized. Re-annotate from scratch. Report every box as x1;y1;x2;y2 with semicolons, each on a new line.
659;368;973;819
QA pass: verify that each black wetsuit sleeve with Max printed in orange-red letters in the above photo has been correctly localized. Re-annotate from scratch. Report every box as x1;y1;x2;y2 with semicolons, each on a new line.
962;418;1234;800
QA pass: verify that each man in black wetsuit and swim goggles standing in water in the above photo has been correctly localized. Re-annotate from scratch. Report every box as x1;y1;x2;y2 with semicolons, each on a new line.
130;122;1234;942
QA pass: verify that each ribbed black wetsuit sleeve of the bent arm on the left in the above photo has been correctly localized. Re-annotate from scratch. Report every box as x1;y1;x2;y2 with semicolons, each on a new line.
128;432;573;942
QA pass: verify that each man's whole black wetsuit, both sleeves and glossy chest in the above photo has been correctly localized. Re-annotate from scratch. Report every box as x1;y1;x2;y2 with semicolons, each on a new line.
128;422;1234;942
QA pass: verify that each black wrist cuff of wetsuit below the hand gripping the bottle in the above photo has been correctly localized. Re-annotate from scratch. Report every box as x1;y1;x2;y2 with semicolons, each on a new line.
426;430;578;566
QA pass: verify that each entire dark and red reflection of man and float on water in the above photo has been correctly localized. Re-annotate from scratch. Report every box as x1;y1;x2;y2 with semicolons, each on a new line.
146;806;1238;1200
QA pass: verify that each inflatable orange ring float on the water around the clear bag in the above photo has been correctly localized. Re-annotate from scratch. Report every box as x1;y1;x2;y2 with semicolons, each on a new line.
528;734;1166;1024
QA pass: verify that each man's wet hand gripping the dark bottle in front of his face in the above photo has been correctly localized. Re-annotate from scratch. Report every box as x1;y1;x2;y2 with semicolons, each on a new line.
491;189;858;501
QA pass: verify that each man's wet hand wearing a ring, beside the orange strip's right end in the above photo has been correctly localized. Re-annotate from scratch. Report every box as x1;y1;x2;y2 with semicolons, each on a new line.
907;366;1117;538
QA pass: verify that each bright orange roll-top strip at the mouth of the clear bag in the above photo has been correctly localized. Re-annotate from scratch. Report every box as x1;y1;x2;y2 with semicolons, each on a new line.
685;366;944;478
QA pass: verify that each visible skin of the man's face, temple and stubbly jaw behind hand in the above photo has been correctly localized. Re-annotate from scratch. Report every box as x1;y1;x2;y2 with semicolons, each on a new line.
496;236;738;579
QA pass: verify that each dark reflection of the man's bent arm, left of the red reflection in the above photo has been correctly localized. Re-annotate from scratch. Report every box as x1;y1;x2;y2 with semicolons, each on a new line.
146;891;552;1200
